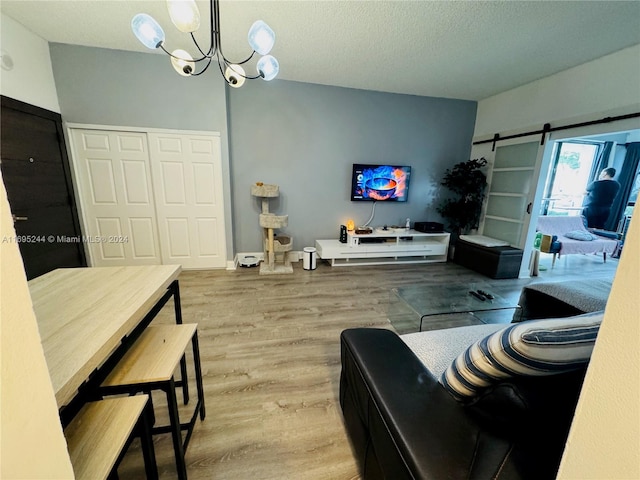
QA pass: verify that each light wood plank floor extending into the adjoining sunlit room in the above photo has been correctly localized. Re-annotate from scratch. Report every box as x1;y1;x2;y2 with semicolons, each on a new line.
119;255;617;480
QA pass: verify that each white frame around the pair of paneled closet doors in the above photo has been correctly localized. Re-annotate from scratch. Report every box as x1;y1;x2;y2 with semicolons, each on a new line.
63;122;230;270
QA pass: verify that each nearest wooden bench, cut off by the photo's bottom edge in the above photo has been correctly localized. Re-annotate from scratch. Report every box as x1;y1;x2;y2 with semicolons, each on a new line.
64;395;158;480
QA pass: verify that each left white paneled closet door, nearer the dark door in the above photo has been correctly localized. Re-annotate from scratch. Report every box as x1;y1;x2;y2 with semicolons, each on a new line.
71;129;161;266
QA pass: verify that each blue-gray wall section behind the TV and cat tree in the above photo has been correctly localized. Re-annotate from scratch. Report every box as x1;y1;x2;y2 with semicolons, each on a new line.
228;80;476;252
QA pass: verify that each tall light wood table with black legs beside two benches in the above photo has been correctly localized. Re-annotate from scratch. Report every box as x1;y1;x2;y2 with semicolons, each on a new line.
29;265;182;414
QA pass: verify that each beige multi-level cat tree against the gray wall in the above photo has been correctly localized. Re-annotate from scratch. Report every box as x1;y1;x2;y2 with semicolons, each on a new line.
251;182;293;275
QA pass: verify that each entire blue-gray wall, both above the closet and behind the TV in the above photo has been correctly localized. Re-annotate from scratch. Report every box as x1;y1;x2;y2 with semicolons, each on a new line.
51;44;477;259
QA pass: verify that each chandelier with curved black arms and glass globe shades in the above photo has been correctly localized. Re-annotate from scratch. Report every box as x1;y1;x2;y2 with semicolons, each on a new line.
131;0;280;88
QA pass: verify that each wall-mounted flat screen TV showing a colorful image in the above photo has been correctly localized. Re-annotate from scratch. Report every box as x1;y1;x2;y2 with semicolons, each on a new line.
351;163;411;202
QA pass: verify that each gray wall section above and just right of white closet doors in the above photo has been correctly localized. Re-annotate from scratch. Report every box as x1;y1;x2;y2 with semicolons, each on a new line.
50;43;233;259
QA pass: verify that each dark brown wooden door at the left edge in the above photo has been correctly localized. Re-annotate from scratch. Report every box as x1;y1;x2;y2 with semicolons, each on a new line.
0;96;87;279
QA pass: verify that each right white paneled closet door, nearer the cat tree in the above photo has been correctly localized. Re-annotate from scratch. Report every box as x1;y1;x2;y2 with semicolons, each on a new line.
148;133;226;269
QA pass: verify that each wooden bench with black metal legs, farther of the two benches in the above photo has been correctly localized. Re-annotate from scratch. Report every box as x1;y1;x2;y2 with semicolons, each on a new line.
100;324;205;480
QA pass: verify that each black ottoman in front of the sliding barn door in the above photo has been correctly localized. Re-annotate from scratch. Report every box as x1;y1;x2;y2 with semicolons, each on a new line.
453;239;522;278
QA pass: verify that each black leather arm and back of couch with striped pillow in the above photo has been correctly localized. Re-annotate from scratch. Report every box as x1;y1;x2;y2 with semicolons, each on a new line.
340;328;584;480
